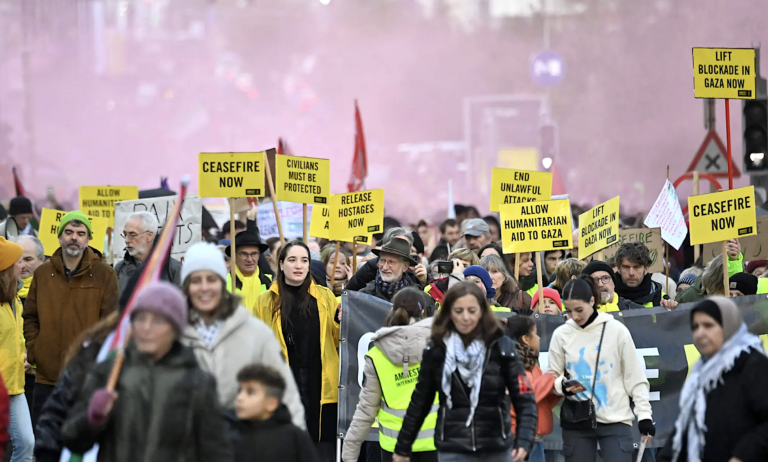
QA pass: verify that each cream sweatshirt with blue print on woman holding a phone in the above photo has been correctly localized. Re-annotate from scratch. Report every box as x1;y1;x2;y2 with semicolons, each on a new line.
547;313;653;425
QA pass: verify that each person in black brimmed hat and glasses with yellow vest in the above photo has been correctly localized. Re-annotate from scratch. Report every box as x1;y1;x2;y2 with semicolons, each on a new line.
224;231;272;313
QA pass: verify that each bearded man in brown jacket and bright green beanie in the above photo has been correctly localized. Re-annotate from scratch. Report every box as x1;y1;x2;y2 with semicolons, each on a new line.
23;211;118;426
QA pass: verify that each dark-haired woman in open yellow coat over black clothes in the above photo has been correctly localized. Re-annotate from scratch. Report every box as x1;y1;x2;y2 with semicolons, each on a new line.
254;241;340;461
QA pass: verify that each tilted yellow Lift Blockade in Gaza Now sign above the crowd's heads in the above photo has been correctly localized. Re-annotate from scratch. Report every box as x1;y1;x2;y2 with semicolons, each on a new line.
579;196;619;259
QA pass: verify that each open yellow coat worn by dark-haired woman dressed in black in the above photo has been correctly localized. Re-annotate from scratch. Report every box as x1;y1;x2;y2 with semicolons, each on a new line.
253;281;341;405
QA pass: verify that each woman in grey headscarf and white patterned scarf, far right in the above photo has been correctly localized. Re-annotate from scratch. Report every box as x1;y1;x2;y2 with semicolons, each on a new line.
659;297;768;462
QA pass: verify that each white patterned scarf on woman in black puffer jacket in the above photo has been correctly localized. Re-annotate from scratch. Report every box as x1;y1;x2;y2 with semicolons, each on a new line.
443;332;486;427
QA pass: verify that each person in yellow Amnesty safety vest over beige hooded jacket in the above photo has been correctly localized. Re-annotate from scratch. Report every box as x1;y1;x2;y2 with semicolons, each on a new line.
341;287;439;462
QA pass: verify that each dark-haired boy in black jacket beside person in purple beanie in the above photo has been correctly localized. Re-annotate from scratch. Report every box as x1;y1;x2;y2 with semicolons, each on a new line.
233;364;318;462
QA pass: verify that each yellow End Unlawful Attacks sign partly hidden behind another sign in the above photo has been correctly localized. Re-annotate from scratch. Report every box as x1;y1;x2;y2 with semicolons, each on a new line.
491;168;552;212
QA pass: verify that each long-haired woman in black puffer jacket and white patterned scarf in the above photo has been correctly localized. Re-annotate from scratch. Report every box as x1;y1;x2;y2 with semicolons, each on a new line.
393;282;537;462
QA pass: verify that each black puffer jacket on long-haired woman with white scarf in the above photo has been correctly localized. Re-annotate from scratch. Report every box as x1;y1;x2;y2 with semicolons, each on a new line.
395;331;537;457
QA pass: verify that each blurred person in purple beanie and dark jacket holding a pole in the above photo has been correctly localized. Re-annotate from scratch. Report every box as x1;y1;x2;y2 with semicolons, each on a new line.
62;282;233;462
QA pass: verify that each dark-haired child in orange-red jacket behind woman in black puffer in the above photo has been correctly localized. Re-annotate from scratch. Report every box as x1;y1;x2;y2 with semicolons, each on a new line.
507;316;560;462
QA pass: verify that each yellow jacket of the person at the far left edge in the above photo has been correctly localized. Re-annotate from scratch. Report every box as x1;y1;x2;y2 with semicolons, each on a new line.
0;296;26;396
